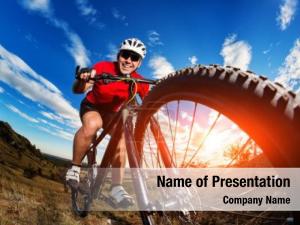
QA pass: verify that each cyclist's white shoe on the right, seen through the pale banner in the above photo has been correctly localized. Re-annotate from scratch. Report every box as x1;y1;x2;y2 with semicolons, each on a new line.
109;185;134;208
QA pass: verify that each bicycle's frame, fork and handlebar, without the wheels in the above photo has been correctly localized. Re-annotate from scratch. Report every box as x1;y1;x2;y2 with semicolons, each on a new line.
72;71;174;221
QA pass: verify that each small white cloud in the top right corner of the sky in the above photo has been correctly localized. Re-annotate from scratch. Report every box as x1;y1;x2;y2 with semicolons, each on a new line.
277;0;297;30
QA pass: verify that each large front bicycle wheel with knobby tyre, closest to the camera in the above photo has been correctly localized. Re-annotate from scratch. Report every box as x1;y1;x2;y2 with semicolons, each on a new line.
135;65;300;224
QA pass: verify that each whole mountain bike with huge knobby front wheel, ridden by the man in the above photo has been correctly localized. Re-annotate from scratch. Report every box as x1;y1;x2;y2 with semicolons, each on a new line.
72;65;300;224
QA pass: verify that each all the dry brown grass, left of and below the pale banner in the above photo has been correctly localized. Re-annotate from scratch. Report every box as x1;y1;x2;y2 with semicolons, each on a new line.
0;163;288;225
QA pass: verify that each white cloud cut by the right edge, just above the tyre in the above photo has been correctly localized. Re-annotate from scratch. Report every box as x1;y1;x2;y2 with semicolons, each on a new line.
275;39;300;93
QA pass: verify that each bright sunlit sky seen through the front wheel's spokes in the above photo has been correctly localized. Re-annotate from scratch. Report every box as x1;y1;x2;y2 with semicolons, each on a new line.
144;103;260;167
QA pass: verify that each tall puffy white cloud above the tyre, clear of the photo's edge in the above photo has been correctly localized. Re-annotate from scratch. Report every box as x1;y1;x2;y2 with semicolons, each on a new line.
220;35;252;70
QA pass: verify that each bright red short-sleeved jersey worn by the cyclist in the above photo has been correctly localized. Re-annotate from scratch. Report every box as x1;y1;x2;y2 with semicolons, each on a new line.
86;62;149;112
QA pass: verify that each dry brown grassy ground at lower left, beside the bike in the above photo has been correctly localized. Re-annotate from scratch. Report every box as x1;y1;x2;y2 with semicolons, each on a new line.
0;164;140;225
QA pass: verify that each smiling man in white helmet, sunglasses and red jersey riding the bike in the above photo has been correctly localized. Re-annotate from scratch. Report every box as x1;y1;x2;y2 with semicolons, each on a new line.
66;38;149;205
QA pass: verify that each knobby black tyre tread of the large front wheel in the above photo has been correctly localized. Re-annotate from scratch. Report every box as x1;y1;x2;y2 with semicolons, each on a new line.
135;64;300;166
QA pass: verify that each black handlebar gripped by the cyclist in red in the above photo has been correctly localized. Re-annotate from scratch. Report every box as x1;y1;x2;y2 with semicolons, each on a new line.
75;66;157;85
